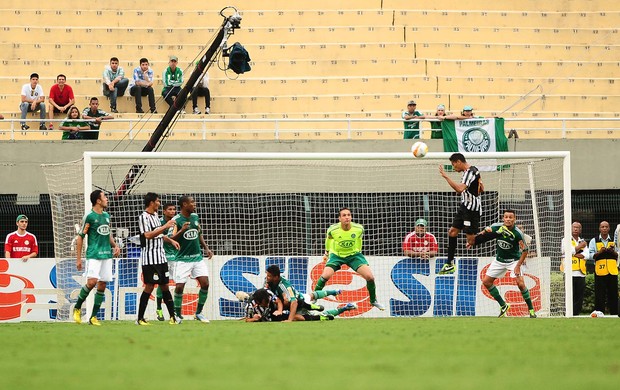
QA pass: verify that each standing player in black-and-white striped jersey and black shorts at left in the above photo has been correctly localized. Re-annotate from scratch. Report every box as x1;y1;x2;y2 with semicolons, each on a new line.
136;192;180;325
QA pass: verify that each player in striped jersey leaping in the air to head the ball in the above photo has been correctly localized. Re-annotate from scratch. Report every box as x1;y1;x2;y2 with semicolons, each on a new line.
439;153;484;275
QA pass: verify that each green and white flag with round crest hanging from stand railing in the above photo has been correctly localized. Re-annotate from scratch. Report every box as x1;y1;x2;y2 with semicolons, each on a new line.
441;118;508;171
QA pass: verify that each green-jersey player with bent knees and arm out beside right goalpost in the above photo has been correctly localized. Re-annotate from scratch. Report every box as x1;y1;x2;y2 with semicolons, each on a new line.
467;210;536;318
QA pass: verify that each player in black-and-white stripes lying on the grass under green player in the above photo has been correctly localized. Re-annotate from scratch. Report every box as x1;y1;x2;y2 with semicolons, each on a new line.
236;288;357;322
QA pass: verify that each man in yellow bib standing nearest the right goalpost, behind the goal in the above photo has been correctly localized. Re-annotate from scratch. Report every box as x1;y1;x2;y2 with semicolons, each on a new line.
562;221;590;316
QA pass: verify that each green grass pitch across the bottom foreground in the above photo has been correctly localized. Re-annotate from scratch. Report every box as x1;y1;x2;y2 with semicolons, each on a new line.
0;317;620;390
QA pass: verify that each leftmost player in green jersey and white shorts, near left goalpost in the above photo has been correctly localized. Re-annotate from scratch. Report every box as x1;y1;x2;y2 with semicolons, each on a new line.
73;190;120;326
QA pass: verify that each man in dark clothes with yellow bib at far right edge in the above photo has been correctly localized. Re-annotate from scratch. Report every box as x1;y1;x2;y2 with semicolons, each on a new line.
589;221;618;315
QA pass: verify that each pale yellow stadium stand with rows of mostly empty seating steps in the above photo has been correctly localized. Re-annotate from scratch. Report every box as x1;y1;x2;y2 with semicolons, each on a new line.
0;0;620;139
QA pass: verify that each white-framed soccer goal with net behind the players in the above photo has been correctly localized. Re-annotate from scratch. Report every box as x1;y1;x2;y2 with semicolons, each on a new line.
44;152;572;319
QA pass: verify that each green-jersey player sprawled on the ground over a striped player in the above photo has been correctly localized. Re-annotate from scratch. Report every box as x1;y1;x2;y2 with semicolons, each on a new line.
265;264;357;322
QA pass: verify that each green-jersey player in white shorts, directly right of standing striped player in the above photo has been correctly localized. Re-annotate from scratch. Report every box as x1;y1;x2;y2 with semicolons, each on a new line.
172;196;213;323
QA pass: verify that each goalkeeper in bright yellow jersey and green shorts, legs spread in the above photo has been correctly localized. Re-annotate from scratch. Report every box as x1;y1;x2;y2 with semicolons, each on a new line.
314;207;385;310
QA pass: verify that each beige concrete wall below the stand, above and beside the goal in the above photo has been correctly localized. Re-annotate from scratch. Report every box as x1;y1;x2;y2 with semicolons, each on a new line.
0;139;620;195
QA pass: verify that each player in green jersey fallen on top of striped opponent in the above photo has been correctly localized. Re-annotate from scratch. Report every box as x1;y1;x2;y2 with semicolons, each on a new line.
265;264;357;321
